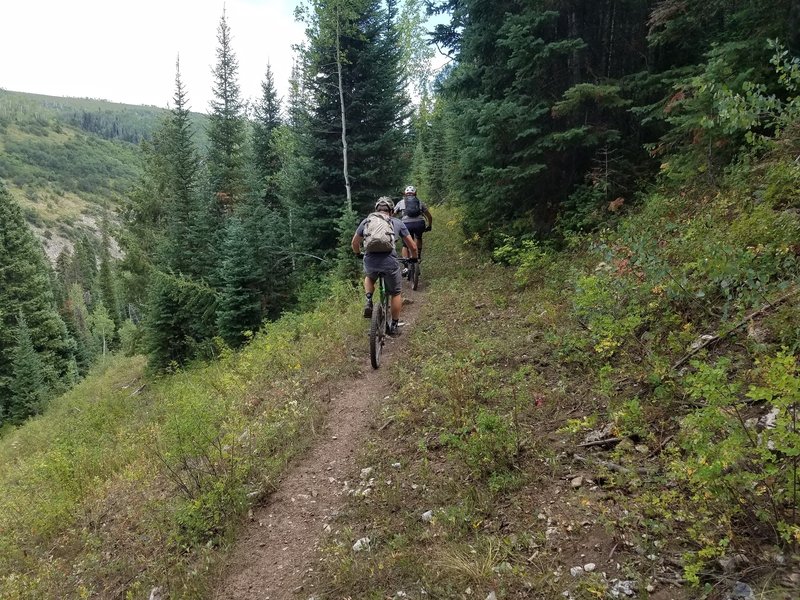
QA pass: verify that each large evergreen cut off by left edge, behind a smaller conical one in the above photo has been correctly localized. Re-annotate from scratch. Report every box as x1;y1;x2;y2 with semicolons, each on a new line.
0;182;74;414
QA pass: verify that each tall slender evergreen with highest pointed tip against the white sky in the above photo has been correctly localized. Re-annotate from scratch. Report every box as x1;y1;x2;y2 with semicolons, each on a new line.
208;11;246;205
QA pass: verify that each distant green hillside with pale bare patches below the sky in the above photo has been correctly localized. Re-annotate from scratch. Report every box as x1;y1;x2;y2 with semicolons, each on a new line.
0;90;205;260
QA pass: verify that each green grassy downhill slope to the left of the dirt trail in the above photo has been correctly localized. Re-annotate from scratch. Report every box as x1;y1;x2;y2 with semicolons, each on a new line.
0;284;364;600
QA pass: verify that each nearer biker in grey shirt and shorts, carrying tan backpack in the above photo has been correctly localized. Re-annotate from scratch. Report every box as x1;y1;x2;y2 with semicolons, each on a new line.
351;196;417;335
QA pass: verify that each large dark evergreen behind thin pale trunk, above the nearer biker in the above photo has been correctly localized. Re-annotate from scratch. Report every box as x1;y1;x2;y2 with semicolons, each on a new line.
304;0;408;251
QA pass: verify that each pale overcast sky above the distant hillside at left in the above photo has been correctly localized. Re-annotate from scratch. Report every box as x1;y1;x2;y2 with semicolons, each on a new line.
0;0;303;112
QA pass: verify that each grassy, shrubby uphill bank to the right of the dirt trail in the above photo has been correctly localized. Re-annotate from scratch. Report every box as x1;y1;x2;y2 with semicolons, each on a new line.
306;199;800;600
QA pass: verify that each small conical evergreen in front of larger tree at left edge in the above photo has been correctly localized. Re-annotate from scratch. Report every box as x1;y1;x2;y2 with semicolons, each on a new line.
7;313;48;423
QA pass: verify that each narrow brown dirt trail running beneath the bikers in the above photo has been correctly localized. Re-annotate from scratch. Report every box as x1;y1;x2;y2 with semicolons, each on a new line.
213;289;424;600
